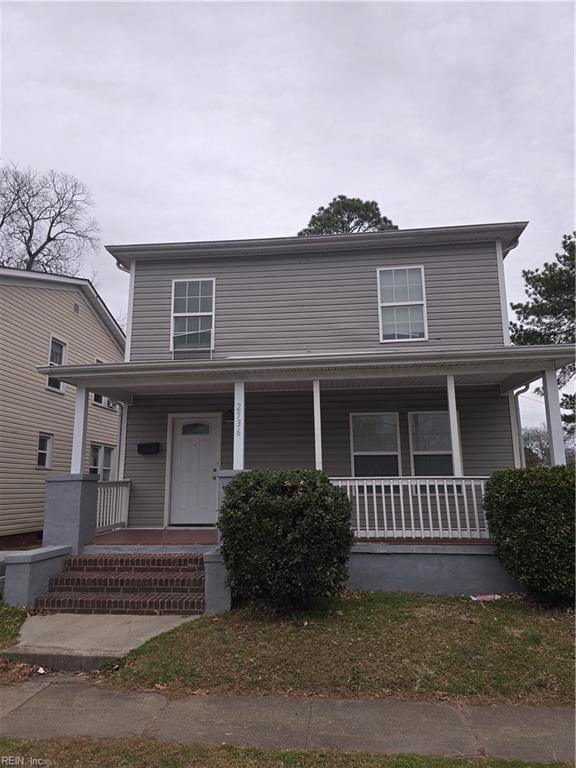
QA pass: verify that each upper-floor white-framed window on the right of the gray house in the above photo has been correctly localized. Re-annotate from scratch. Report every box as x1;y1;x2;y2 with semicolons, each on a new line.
378;267;428;342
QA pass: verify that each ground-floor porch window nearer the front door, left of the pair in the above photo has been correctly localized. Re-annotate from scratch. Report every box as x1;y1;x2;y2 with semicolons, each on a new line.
350;413;400;477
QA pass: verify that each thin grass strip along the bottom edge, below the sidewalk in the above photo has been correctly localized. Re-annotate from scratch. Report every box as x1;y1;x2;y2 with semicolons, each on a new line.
0;738;562;768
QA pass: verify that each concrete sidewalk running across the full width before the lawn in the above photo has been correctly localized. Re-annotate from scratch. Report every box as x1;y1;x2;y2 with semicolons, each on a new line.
0;677;574;764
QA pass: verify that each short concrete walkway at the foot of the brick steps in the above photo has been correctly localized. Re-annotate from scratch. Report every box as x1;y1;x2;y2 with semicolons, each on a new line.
0;613;196;672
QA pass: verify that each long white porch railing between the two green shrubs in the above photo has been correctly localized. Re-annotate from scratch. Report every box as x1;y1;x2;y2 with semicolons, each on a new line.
332;477;489;539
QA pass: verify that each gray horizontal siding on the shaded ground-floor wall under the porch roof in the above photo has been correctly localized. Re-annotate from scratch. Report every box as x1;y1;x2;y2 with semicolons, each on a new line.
125;387;513;527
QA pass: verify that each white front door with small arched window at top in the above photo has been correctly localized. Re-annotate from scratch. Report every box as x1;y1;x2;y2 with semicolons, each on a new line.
169;415;220;525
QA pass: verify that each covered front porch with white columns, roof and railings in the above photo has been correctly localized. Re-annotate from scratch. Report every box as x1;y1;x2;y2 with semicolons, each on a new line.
44;346;571;543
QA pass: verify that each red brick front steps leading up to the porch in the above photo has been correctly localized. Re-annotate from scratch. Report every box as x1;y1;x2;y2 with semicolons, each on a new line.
36;554;204;616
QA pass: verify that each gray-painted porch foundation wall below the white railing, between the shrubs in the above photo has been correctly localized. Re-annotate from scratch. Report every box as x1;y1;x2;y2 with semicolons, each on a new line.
348;544;525;595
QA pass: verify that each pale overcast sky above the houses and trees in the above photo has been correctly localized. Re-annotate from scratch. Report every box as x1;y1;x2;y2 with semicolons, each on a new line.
0;2;574;423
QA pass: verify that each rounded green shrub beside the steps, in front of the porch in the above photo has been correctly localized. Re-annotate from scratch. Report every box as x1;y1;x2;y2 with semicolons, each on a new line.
218;469;354;607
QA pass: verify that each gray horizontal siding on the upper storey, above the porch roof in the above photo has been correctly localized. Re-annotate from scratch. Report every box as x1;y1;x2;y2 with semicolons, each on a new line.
131;243;503;361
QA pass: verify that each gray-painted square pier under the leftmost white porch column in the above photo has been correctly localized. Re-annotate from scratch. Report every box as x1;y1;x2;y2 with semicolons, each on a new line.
42;475;98;555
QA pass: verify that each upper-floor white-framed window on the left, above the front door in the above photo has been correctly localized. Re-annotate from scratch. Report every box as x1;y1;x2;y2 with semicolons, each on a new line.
172;279;214;352
